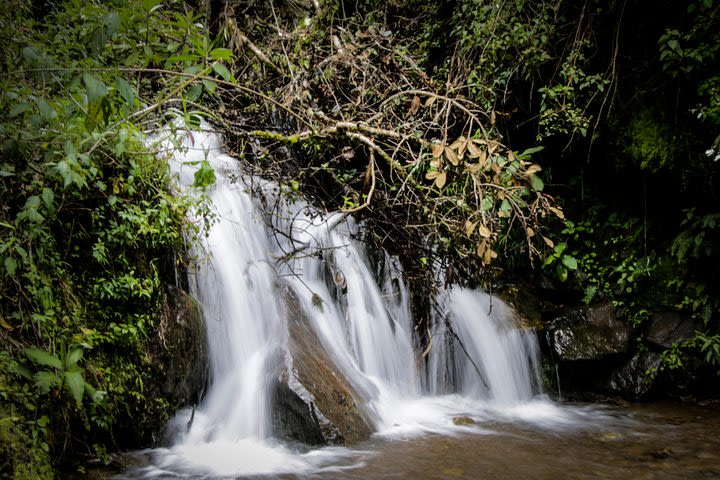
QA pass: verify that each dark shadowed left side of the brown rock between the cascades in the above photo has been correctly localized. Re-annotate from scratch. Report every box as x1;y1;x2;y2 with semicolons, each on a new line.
271;381;325;445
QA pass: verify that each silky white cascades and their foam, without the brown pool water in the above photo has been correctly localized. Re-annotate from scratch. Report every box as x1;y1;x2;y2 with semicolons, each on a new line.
136;125;558;477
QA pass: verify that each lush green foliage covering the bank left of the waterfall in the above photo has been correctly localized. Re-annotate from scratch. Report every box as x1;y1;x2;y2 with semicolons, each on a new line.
0;0;219;478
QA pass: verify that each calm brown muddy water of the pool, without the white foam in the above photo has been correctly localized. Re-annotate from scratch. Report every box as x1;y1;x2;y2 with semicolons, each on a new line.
310;404;720;479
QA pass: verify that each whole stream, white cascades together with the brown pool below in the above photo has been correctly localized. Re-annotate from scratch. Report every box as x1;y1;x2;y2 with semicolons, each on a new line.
112;129;720;479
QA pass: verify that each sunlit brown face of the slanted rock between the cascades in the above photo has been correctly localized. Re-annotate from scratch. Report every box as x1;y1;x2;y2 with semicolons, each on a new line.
285;289;374;445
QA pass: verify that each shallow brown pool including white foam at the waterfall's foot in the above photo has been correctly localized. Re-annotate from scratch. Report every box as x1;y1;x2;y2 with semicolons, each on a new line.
108;402;720;480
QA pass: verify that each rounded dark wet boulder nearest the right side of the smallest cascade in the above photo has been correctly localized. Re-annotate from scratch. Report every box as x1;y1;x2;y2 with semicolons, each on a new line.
549;303;632;361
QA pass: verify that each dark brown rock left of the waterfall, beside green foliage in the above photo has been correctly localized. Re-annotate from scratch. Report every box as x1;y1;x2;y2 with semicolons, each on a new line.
154;286;208;407
